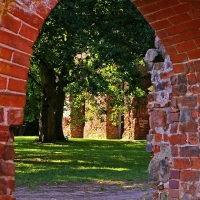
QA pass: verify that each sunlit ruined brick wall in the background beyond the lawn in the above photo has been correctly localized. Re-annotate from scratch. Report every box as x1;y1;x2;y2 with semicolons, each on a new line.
63;94;149;140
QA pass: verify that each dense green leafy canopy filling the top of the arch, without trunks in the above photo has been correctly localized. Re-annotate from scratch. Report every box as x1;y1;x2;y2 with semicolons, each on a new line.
26;0;154;127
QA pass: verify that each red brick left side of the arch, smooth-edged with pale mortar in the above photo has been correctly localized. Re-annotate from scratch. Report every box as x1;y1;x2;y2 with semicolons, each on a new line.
0;0;57;200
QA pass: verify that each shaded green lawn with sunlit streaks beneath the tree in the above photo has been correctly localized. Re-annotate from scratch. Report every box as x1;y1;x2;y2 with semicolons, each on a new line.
15;137;150;187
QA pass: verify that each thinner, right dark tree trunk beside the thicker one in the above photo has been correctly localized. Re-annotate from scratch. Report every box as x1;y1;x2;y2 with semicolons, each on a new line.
54;83;66;141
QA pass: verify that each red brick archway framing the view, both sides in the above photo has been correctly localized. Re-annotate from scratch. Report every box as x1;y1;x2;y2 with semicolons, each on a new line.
0;0;200;200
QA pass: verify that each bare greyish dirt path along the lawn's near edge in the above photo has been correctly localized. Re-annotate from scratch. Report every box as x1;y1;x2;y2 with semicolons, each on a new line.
15;182;153;200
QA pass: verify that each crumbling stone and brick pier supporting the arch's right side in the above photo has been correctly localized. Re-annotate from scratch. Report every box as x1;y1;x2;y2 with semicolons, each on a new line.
145;37;200;199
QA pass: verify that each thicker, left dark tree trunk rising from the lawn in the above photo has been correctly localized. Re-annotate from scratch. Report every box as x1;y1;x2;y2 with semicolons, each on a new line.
39;62;56;142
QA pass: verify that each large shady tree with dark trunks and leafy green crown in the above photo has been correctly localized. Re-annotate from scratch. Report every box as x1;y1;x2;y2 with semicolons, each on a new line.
29;0;154;142
